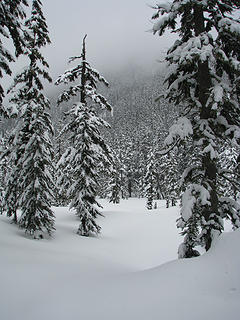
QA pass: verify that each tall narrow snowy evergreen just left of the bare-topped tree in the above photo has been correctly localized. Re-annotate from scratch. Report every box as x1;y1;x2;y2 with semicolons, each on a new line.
6;0;54;237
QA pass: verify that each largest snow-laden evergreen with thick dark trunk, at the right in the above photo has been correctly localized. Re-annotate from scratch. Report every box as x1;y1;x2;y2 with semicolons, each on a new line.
153;0;240;257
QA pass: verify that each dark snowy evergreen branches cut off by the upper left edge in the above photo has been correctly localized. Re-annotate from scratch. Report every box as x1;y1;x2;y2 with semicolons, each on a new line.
0;0;27;110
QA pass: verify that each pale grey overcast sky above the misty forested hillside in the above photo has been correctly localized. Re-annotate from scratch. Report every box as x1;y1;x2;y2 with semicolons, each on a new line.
42;0;174;76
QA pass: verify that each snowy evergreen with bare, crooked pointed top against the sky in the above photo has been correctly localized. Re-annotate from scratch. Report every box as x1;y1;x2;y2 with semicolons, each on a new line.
56;36;112;236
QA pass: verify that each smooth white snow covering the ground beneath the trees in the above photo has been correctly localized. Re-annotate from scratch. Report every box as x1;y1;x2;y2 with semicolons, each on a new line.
0;199;240;320
